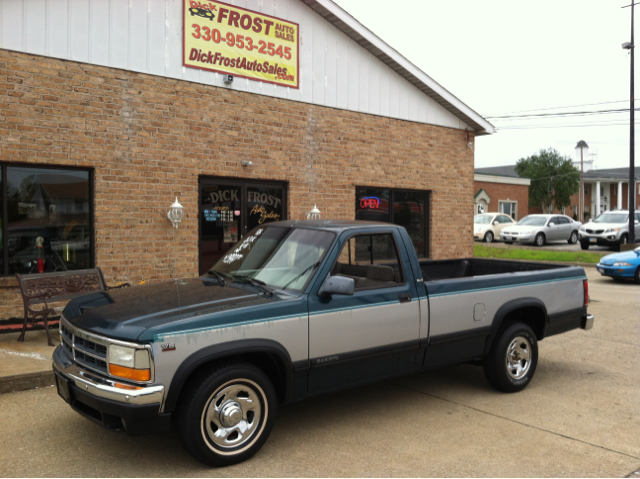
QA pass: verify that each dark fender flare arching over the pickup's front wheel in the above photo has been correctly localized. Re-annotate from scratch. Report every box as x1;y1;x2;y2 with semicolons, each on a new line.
164;339;292;413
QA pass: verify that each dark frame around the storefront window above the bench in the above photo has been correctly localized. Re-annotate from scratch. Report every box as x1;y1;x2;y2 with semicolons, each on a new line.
0;162;96;278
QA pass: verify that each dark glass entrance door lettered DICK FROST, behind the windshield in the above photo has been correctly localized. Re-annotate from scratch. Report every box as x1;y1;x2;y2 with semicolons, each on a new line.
199;177;287;274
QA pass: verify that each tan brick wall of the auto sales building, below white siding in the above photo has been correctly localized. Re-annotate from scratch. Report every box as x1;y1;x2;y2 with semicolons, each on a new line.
0;50;473;319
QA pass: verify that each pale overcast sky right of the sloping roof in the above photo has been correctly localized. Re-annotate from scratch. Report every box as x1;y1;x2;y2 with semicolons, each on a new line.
334;0;640;169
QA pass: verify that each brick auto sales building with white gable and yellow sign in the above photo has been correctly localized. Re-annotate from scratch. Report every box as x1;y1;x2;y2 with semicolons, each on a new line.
0;0;494;319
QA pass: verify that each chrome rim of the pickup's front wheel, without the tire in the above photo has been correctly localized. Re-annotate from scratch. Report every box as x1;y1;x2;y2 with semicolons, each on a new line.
202;379;268;454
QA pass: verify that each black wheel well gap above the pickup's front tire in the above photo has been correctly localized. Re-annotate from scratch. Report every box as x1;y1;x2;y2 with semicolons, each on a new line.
175;352;289;403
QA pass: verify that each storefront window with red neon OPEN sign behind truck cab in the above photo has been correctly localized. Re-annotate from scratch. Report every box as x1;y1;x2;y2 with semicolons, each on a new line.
356;187;429;258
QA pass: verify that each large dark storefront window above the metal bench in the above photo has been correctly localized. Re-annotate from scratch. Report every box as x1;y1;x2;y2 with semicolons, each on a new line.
1;166;93;275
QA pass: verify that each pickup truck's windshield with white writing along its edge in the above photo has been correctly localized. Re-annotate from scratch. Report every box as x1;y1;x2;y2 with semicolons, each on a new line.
211;226;335;292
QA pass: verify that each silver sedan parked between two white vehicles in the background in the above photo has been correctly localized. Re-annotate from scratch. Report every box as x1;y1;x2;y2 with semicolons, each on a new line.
500;215;582;246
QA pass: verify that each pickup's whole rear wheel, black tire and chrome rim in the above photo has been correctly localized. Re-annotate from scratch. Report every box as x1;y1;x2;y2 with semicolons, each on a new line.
483;323;538;393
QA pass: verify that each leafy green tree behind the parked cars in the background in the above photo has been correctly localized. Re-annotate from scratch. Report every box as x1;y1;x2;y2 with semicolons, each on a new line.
516;148;580;213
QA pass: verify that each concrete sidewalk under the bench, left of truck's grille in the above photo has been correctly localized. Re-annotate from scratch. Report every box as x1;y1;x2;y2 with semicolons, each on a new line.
0;329;60;393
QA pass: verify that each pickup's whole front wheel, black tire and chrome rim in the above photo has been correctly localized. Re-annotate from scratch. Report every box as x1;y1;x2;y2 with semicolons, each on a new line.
177;363;278;467
